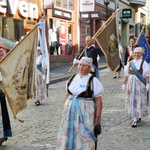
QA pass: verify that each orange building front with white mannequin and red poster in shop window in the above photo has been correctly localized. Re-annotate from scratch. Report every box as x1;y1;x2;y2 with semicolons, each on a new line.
45;0;79;68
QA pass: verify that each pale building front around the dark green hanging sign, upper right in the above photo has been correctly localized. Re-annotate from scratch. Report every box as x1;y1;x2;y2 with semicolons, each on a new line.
119;0;149;47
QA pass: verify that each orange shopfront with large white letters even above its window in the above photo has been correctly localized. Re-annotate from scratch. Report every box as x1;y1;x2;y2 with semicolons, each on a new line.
0;0;42;42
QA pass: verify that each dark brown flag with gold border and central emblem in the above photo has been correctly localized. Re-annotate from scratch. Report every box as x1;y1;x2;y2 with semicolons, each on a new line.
93;10;120;72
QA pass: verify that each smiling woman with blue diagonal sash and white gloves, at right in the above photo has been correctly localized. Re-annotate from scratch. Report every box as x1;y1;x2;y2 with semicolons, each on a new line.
122;47;150;127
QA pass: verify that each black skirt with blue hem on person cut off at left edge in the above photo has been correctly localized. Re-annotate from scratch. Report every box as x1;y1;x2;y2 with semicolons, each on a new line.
0;89;12;138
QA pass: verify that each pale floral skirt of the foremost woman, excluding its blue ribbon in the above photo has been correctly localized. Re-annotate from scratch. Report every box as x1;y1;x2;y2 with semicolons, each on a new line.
56;99;95;150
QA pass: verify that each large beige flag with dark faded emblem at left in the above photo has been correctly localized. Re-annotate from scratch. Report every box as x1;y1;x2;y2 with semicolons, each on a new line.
0;26;38;118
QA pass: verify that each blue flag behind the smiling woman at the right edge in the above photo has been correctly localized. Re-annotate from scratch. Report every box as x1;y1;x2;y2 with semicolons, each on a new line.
137;32;150;63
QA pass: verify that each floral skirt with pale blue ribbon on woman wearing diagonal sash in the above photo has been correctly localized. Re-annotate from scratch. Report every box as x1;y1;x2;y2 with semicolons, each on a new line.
125;75;148;118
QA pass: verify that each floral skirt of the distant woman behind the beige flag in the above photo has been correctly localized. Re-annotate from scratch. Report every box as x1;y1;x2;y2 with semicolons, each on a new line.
33;69;47;101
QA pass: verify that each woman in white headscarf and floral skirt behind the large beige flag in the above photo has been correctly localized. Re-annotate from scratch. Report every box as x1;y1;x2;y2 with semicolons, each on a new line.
34;47;47;106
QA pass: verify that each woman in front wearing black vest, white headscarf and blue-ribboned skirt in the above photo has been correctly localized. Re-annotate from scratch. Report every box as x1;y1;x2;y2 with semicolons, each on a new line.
56;57;103;150
